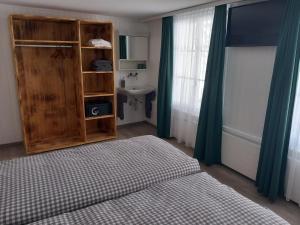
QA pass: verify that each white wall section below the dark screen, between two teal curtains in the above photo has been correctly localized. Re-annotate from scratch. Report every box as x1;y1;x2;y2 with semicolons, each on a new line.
222;47;276;179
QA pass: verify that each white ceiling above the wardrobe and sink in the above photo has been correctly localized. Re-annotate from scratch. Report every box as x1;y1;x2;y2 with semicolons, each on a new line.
0;0;216;19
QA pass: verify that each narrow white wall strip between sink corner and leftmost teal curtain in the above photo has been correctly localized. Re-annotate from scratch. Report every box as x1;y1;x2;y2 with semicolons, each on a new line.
147;19;162;125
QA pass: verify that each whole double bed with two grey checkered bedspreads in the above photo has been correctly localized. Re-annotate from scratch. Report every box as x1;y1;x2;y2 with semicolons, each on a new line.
0;136;288;225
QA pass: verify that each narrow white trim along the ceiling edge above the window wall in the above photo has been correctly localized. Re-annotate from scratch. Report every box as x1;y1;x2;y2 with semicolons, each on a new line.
142;0;268;23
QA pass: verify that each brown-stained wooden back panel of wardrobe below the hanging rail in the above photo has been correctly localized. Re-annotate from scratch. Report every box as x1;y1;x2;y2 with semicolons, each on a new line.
16;47;81;143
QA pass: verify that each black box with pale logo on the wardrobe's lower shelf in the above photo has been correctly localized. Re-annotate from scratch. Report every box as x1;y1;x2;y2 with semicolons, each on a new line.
85;101;112;117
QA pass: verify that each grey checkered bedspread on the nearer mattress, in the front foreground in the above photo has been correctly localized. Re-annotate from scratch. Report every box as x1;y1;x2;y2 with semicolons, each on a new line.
32;173;288;225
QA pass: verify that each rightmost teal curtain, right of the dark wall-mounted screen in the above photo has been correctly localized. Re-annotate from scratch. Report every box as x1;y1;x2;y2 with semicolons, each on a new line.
256;0;300;200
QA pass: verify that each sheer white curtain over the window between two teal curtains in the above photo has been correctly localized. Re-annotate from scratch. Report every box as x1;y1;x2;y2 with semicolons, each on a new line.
171;8;214;147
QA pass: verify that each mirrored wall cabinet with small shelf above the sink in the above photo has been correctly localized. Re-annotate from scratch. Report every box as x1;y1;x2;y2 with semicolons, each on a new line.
119;35;148;70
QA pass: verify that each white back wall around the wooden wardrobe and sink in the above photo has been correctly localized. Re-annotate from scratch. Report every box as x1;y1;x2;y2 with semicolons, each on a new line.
0;4;148;144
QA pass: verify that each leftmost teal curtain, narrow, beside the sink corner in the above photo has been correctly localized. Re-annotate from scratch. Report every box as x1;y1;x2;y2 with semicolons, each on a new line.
157;17;173;138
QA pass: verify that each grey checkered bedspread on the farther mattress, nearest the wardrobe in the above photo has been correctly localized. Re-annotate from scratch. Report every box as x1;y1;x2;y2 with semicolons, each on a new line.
0;136;200;225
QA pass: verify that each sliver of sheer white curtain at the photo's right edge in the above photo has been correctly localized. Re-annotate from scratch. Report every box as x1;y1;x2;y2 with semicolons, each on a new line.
285;62;300;206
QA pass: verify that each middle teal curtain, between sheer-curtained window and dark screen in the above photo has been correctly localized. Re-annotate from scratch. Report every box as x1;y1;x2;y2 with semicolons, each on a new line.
194;5;227;165
